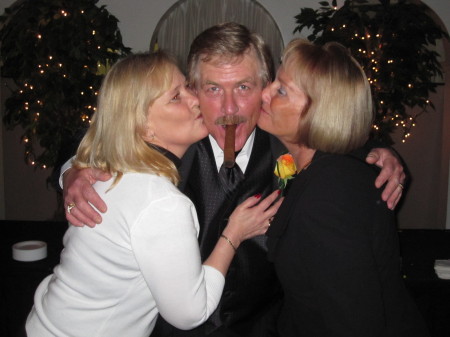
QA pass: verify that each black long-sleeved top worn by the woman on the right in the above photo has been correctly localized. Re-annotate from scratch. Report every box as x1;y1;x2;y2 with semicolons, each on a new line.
267;151;428;337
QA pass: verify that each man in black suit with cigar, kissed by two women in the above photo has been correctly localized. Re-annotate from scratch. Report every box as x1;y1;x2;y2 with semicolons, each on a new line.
160;23;285;336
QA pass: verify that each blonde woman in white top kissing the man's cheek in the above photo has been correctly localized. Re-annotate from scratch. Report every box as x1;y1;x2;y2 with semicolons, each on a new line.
26;52;281;337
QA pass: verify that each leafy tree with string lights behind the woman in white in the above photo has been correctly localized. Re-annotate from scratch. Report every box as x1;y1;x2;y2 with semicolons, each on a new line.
0;0;130;168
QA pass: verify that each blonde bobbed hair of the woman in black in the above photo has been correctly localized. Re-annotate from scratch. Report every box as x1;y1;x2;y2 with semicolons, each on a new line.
282;39;373;153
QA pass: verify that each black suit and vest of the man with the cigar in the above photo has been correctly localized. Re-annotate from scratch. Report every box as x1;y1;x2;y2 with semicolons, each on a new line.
152;128;286;337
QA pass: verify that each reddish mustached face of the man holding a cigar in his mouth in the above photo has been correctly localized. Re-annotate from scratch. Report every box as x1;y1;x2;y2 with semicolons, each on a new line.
196;52;263;151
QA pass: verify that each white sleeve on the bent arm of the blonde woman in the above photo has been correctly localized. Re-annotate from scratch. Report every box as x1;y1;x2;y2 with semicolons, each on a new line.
130;195;225;330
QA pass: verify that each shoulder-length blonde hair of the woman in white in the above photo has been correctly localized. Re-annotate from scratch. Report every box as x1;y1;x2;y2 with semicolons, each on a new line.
74;51;179;186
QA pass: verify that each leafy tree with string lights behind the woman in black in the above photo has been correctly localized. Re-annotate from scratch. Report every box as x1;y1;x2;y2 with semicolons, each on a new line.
294;0;449;143
